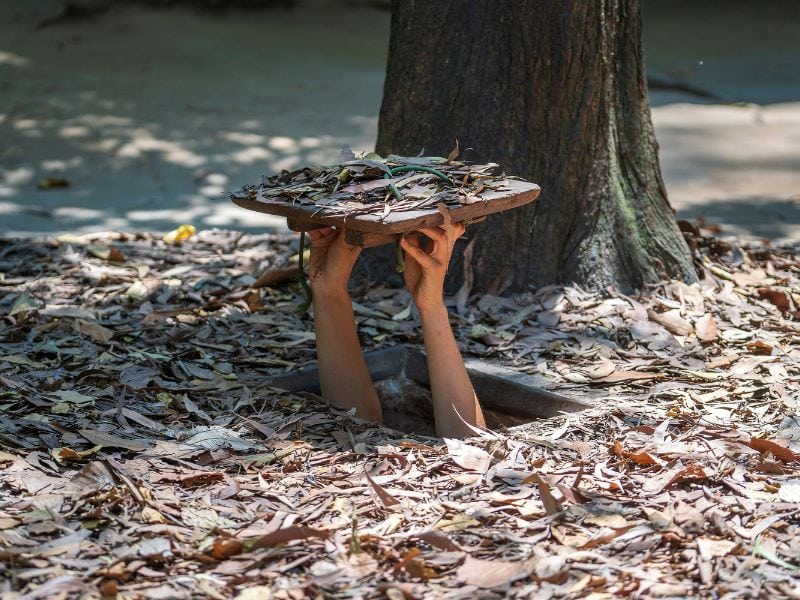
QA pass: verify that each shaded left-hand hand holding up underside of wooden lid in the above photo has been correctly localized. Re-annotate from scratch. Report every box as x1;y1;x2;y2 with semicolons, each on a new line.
308;227;361;293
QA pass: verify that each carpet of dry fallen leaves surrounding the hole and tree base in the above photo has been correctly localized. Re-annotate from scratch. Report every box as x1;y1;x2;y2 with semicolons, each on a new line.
0;227;800;600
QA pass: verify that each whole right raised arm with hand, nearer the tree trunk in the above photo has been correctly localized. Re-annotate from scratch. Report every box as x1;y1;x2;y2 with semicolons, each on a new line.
401;223;486;437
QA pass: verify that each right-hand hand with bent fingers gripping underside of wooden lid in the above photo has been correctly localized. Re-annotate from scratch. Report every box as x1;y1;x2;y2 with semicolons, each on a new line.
400;223;465;313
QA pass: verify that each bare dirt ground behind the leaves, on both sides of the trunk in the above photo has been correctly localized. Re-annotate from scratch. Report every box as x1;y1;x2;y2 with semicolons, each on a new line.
0;0;800;240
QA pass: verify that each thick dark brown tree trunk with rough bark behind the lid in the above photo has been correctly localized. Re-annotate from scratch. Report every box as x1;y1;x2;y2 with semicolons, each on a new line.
377;0;696;291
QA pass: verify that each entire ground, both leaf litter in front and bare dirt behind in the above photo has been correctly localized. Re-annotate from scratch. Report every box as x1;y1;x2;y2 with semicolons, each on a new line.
0;0;800;600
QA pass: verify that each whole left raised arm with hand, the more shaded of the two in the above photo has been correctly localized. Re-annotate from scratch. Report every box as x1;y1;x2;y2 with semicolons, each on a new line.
308;228;383;423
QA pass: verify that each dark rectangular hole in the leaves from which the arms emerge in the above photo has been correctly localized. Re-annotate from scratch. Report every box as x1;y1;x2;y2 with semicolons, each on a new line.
269;346;591;437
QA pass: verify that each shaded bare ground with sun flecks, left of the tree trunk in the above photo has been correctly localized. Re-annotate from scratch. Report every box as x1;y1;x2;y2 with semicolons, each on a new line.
0;2;388;235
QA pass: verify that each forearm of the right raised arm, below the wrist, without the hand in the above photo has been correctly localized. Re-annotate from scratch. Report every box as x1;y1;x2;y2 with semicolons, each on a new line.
420;304;485;437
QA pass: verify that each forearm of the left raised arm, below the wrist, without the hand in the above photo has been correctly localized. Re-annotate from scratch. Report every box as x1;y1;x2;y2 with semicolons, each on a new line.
313;289;383;423
